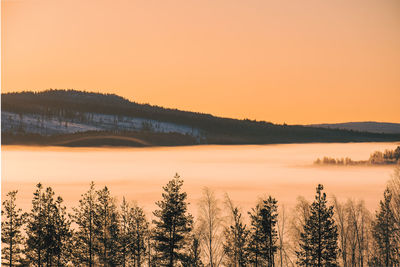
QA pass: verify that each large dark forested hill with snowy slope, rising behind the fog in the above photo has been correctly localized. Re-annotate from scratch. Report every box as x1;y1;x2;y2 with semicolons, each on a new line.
1;90;400;146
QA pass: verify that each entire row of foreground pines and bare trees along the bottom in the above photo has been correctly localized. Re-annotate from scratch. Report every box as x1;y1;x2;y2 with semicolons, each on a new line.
1;171;400;267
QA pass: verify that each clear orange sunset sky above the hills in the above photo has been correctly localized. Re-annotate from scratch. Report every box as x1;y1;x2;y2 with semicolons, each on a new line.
1;0;400;124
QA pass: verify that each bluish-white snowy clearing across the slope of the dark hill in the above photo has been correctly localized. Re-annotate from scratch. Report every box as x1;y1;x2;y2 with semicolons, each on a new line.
1;111;200;137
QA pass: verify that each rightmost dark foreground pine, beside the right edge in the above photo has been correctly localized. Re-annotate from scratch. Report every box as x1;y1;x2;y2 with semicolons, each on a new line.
372;189;400;266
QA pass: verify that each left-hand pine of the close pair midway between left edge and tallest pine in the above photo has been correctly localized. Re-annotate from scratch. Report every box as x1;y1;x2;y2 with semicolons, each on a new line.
73;182;97;267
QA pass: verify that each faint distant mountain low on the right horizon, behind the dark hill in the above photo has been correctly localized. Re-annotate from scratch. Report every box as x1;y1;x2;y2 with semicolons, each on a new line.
308;121;400;134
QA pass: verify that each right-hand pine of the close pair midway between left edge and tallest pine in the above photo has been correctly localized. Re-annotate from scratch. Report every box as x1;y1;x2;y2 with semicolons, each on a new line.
94;186;120;266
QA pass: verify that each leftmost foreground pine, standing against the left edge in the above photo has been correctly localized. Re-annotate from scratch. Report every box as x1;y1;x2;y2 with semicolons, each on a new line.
1;191;26;267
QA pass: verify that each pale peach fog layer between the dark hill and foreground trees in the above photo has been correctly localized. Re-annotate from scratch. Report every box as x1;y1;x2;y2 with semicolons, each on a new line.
1;143;398;218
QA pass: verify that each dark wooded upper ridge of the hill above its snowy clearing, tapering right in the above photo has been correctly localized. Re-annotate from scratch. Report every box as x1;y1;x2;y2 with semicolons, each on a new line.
1;90;399;144
